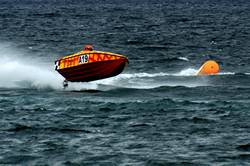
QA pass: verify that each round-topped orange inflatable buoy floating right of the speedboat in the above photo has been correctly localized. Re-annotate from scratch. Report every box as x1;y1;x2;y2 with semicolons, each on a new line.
197;60;220;75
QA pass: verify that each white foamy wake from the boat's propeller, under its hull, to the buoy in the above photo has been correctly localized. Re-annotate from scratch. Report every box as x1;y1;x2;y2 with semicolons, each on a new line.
63;69;203;91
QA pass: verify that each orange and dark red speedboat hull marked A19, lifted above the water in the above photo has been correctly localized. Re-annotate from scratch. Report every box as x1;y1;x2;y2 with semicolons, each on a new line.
56;51;128;82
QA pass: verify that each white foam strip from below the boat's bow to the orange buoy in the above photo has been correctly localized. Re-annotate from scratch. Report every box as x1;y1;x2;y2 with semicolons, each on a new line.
94;69;201;89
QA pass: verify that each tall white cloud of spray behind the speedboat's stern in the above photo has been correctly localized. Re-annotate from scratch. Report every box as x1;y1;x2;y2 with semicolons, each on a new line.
0;44;63;89
